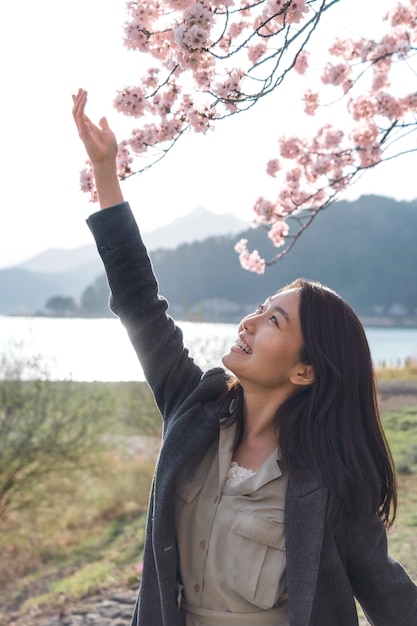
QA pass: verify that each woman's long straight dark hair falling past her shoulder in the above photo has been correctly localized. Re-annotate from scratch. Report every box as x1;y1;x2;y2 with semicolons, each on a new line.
231;278;397;526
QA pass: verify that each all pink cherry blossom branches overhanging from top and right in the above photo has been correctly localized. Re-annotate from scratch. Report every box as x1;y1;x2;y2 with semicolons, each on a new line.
81;0;417;273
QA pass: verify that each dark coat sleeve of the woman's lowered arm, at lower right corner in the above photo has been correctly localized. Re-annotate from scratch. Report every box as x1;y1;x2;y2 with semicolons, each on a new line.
346;515;417;626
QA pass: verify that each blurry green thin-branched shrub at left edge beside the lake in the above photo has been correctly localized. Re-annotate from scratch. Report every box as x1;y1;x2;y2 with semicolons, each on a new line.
0;347;109;519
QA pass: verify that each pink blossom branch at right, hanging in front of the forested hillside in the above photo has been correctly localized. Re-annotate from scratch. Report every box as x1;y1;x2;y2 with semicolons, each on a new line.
238;0;417;272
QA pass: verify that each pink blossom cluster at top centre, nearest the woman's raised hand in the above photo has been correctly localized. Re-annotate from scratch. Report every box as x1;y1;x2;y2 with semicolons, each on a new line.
82;0;322;198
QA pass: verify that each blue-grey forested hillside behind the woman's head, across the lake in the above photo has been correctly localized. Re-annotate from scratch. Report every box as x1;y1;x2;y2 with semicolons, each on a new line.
75;196;417;320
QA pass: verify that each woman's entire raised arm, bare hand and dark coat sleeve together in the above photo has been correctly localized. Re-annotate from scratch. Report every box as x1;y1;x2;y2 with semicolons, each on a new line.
73;89;211;419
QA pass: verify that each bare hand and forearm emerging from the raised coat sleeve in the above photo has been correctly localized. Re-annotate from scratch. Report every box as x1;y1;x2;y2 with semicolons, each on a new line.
72;89;123;209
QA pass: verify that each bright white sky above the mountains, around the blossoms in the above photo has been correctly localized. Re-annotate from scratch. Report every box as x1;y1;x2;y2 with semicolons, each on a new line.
0;0;417;267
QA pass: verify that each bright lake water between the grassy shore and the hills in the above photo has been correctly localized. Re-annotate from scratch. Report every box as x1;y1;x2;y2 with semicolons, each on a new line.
0;316;417;381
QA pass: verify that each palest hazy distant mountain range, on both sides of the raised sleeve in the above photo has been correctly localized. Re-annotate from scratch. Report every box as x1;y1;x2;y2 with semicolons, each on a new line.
0;208;247;314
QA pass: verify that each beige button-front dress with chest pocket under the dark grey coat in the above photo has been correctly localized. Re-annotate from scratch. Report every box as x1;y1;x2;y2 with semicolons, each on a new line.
175;426;289;626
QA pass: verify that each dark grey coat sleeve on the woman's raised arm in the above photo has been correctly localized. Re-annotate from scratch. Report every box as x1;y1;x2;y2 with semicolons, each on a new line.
87;202;202;418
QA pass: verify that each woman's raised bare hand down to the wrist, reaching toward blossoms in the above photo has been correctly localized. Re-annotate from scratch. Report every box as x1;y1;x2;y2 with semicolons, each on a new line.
72;89;117;168
